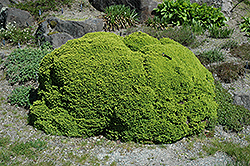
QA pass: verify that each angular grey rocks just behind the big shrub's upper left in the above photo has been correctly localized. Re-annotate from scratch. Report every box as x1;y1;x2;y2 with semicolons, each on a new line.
35;17;103;48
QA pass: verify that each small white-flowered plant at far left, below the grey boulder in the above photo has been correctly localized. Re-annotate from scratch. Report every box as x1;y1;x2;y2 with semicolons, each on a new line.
0;23;35;45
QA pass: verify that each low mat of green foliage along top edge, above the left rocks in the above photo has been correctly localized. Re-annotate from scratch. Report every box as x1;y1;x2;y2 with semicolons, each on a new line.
12;0;73;20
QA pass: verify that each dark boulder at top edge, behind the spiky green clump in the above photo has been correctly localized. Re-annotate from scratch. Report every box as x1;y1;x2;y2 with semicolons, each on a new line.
89;0;159;22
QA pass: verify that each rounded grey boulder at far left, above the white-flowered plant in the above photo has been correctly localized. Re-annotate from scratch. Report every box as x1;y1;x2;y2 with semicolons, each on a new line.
0;7;35;28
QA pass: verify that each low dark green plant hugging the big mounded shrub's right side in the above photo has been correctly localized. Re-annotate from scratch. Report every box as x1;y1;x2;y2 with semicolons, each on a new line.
215;82;250;131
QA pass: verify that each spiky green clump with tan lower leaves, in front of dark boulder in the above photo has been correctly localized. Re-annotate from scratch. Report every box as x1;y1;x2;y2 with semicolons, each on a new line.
103;5;139;31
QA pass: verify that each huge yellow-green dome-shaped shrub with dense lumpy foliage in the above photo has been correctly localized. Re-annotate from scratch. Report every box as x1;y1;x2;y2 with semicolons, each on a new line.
30;32;217;143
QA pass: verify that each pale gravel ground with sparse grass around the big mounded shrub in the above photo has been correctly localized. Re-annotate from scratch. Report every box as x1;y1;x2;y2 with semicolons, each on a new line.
0;0;250;166
